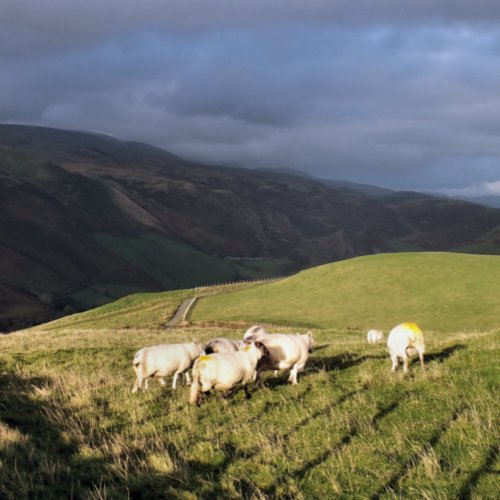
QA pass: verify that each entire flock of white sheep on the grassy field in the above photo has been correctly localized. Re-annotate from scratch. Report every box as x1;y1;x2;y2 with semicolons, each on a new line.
132;322;425;405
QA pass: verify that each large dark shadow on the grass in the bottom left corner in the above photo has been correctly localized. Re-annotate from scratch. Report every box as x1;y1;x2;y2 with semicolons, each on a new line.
0;369;113;498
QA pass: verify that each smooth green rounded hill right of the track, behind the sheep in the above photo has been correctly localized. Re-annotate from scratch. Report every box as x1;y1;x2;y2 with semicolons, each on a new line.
191;253;500;332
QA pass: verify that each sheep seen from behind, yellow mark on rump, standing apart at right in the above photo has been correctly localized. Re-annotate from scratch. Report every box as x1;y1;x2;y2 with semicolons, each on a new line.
387;322;425;373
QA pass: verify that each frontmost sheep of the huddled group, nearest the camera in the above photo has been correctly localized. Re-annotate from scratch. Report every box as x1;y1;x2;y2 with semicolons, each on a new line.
189;342;269;405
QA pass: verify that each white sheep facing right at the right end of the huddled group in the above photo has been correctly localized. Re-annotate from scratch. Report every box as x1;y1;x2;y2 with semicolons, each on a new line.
247;331;313;386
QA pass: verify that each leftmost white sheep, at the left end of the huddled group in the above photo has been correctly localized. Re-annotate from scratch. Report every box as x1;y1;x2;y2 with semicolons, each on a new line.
132;340;202;393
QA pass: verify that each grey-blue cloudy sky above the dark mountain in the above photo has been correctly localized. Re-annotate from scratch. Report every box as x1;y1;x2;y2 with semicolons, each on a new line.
0;0;500;195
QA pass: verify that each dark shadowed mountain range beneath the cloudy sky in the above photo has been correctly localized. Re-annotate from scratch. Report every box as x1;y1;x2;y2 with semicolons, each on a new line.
0;125;500;330
